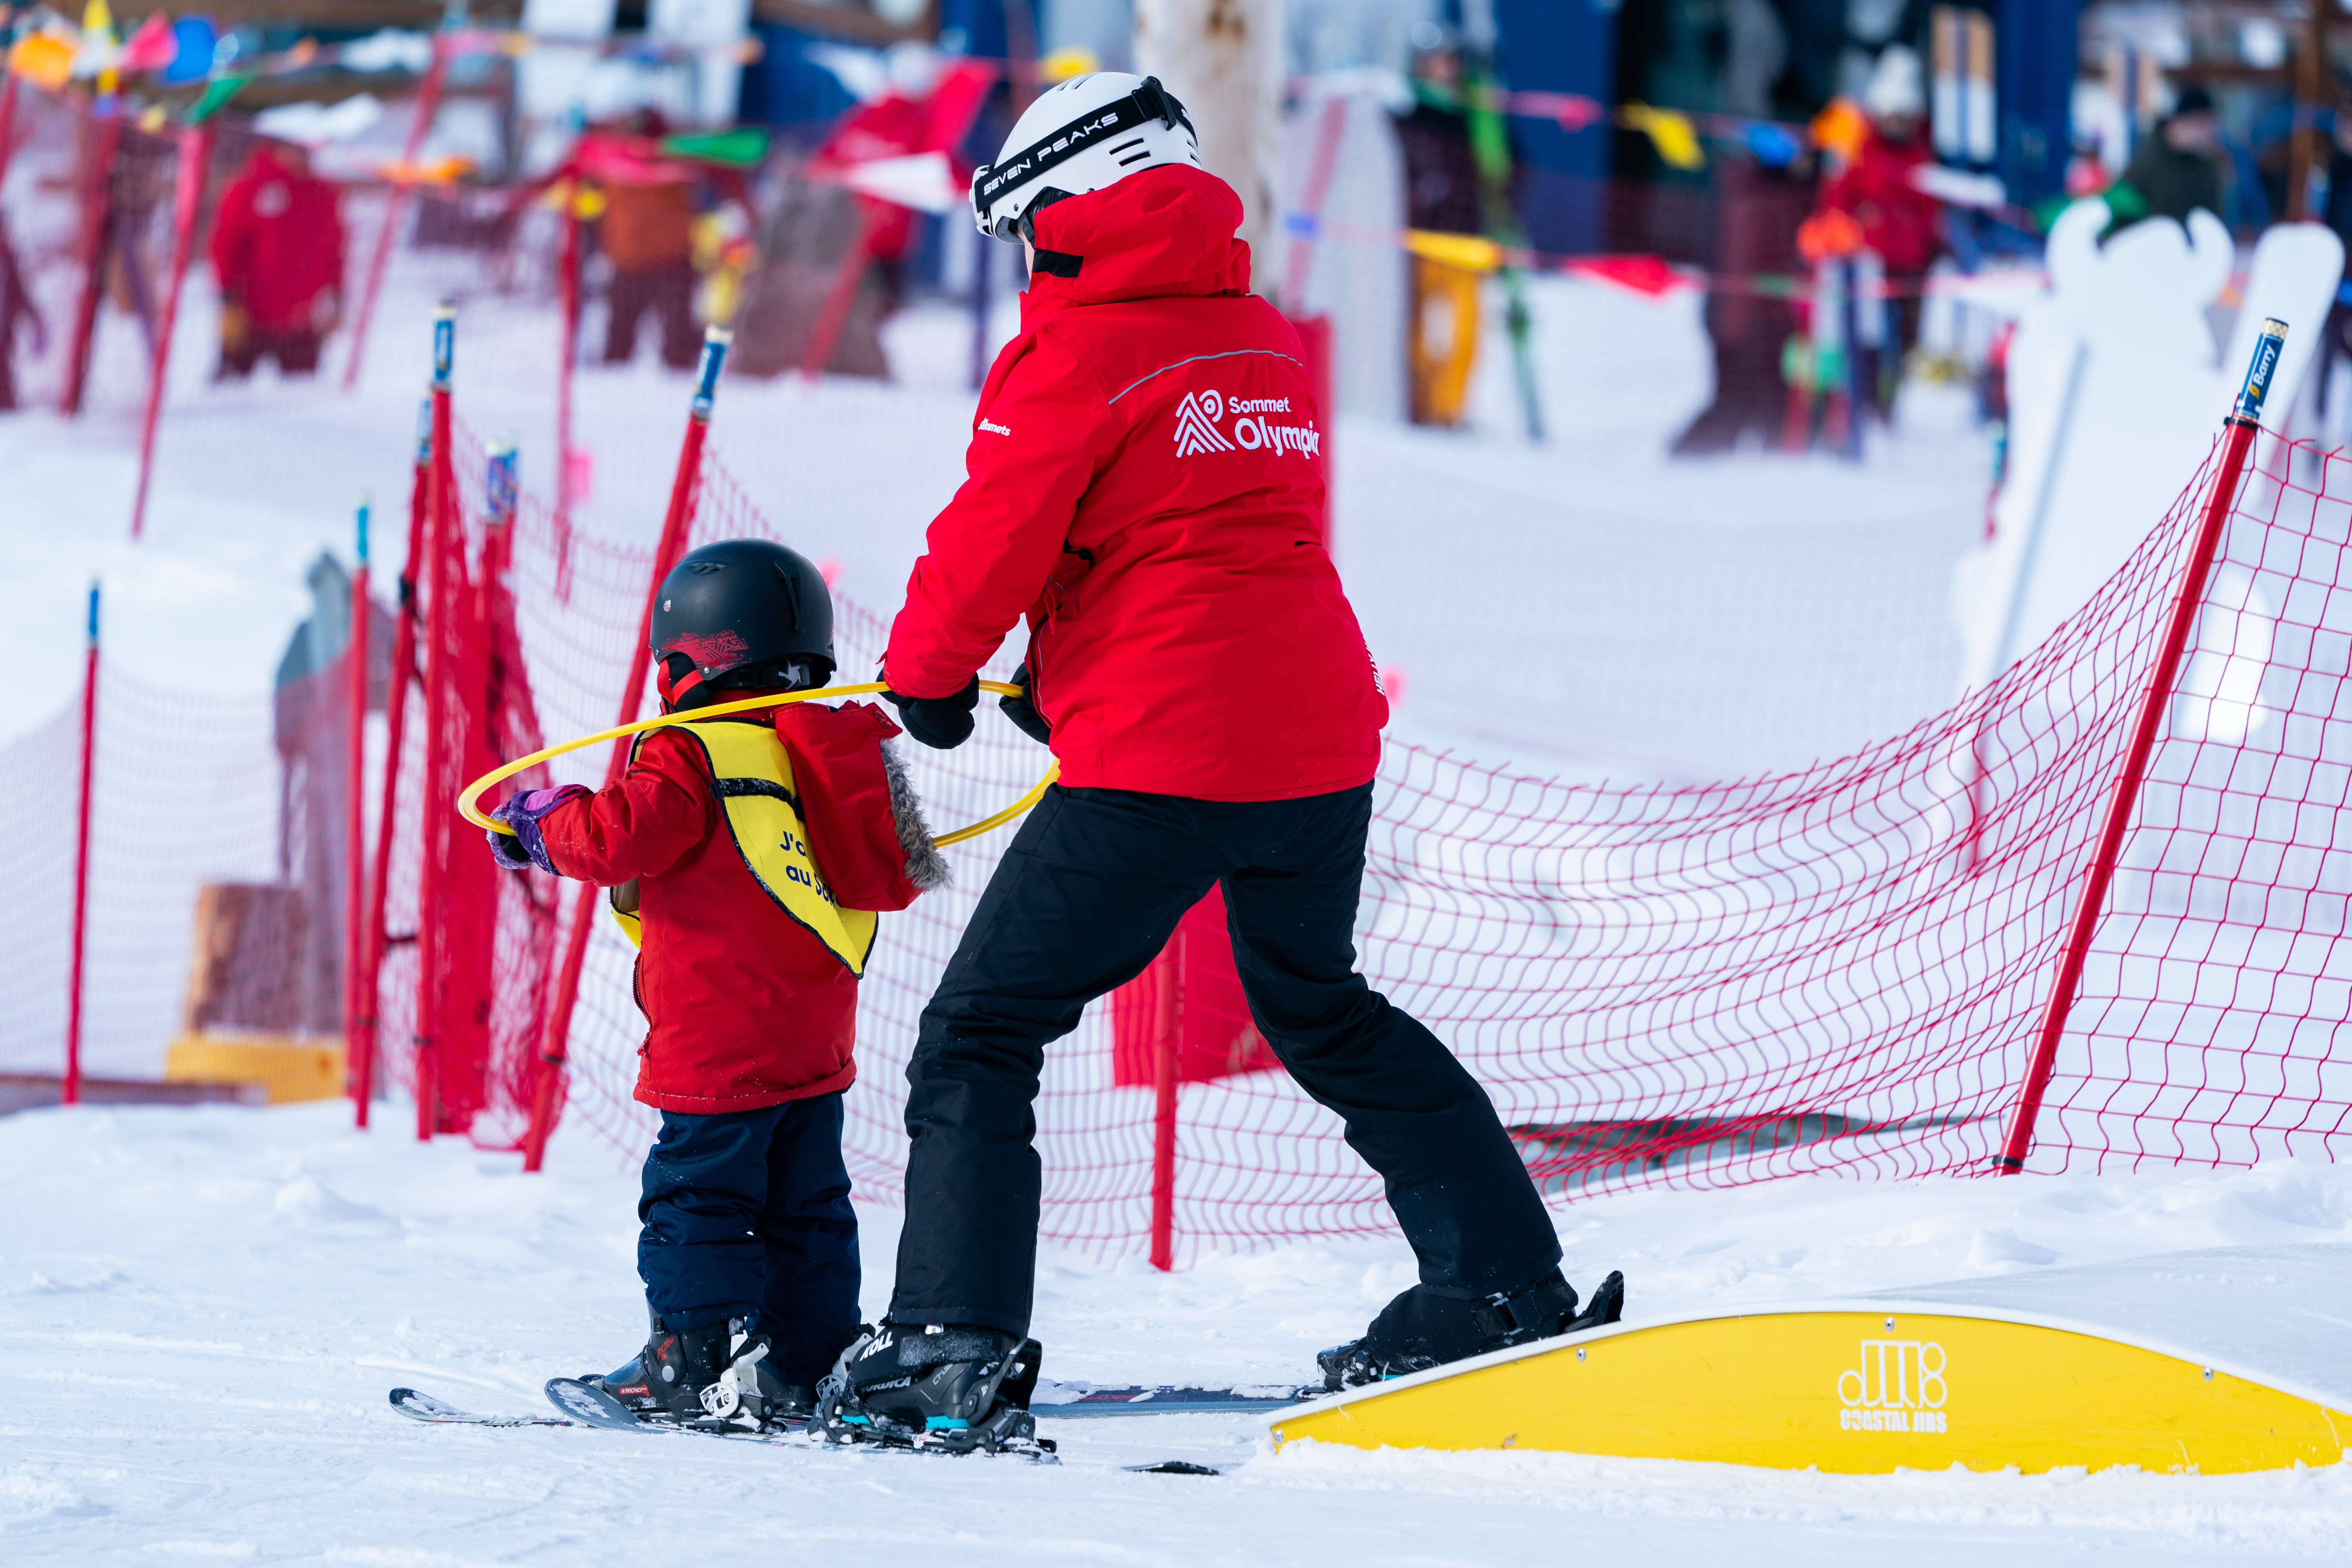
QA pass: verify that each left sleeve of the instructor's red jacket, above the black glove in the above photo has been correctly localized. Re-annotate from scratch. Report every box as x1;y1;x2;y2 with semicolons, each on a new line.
882;336;1120;696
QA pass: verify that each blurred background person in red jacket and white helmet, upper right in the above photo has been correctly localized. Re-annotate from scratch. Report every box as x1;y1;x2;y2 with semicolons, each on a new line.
1818;45;1943;418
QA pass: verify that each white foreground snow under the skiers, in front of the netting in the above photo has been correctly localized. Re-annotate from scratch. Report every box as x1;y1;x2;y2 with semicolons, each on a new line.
0;1105;2352;1568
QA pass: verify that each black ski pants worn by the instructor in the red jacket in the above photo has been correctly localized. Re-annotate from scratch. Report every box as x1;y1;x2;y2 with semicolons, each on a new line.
889;785;1559;1333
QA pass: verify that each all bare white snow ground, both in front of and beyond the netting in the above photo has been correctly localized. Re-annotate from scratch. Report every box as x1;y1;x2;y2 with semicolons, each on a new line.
0;169;2352;1568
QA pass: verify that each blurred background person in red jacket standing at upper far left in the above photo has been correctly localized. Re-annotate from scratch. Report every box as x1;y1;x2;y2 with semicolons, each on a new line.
212;141;343;379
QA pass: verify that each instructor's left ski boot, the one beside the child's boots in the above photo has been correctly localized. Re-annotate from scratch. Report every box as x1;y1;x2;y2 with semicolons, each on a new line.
814;1323;1054;1457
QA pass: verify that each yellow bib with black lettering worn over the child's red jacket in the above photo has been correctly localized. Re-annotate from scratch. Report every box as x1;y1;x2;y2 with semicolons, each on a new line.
612;719;877;976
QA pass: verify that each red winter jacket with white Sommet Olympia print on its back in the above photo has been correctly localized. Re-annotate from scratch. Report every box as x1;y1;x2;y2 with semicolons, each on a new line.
884;165;1388;799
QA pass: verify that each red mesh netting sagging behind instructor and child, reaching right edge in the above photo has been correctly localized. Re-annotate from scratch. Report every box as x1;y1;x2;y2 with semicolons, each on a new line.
376;404;2352;1255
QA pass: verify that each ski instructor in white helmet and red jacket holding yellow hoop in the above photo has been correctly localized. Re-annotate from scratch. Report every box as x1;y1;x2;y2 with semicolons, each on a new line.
823;71;1623;1448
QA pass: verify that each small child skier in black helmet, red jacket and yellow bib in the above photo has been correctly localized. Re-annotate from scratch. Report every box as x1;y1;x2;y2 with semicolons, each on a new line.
489;538;946;1425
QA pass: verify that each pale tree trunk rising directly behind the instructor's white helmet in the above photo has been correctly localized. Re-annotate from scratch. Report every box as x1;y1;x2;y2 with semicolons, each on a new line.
1136;0;1282;292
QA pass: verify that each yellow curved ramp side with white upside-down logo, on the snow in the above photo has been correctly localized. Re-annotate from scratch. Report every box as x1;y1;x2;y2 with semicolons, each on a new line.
1270;1307;2352;1474
